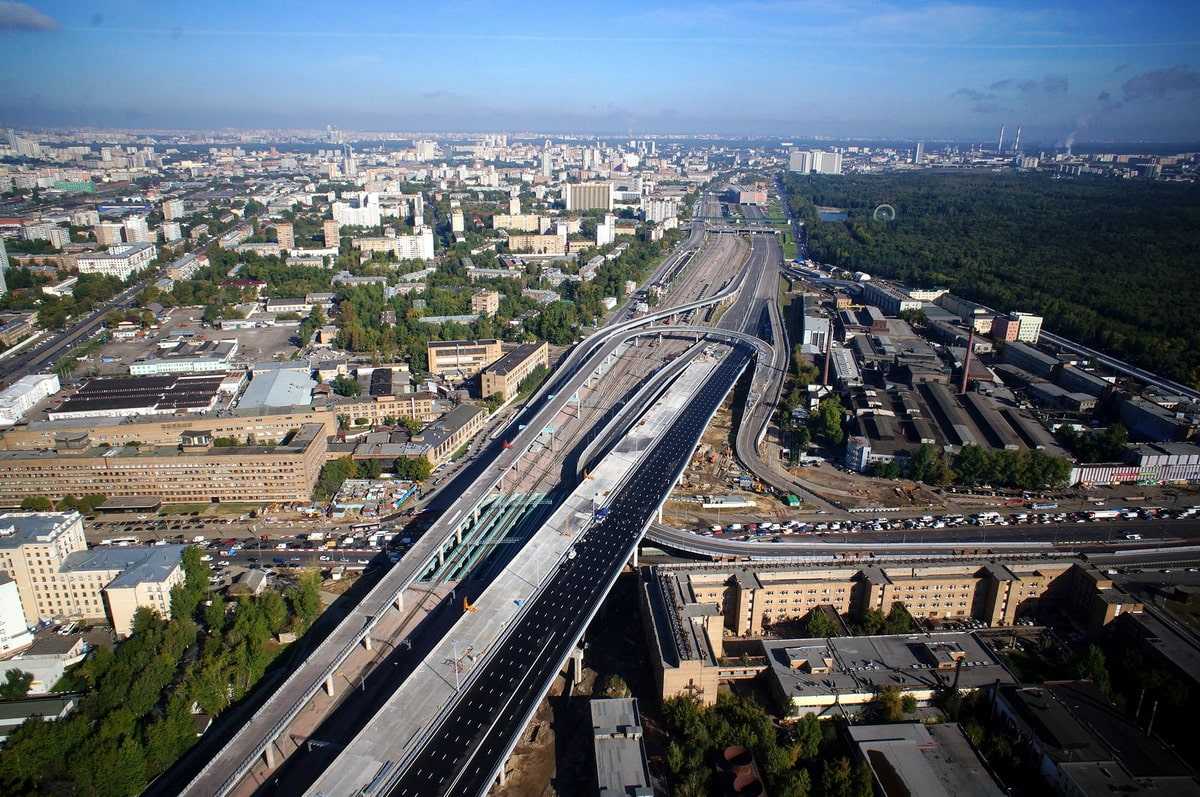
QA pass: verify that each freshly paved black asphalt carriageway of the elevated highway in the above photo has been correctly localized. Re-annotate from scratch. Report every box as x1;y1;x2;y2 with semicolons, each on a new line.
388;347;749;797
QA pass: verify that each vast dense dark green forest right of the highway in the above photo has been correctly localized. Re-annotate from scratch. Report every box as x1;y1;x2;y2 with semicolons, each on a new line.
785;172;1200;386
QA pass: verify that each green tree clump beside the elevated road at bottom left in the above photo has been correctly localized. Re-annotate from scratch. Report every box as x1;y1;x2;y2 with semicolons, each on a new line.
0;549;320;797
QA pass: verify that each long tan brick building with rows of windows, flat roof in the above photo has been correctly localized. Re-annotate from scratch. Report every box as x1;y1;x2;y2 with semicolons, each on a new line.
0;424;326;504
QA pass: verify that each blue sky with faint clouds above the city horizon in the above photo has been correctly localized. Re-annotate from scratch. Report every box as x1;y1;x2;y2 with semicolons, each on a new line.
0;0;1200;144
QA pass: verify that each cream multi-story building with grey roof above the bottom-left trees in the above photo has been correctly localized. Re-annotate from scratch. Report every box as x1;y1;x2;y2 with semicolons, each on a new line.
0;513;185;636
